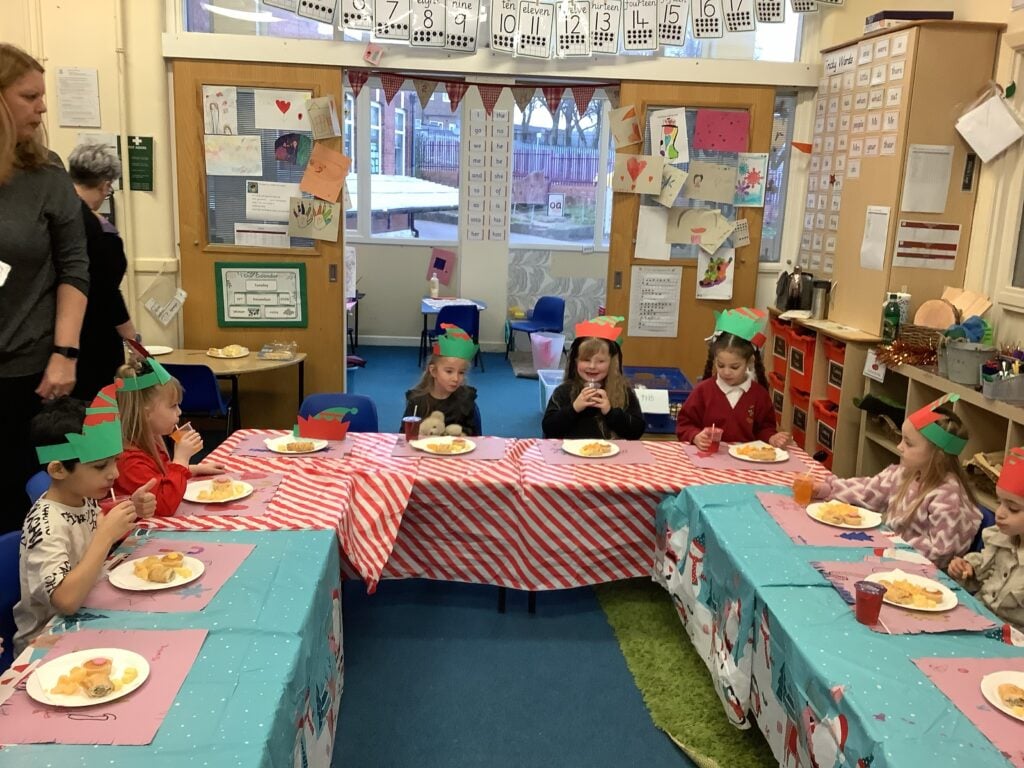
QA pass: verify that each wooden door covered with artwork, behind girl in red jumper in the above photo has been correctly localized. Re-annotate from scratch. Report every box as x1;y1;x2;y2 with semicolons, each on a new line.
607;81;775;382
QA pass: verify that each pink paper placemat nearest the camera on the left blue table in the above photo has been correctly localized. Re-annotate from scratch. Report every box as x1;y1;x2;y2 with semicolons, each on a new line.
0;630;207;745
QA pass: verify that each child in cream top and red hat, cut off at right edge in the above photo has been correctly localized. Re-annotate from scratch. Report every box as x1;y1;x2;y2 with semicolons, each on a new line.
949;447;1024;631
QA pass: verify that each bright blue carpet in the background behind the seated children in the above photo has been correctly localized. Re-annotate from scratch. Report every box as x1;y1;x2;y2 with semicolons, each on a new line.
348;344;542;437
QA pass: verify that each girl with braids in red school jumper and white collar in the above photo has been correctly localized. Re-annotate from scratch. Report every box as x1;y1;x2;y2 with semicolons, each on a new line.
676;307;793;451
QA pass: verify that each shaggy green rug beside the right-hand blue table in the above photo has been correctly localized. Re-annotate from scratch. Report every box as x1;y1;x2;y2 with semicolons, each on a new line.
594;579;778;768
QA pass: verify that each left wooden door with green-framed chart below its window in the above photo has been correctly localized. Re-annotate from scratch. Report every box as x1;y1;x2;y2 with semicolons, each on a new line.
172;59;345;428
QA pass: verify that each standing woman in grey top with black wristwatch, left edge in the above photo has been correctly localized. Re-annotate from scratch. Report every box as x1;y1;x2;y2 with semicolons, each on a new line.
0;43;89;531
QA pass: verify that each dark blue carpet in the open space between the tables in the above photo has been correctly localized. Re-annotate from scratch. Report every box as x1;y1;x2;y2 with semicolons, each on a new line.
334;581;693;768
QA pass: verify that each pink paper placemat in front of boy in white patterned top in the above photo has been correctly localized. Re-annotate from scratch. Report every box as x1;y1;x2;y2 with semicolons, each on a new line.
83;539;254;613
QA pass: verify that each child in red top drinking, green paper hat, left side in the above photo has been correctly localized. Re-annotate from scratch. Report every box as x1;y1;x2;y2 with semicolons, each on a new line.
114;357;224;517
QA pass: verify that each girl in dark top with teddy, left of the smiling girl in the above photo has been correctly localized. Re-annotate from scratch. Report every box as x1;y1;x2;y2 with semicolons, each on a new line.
402;323;477;435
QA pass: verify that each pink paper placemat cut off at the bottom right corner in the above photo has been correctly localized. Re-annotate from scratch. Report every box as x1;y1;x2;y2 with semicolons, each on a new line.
913;657;1024;768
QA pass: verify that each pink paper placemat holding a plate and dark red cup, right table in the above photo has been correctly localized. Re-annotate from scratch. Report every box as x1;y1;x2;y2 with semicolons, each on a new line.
813;557;996;635
